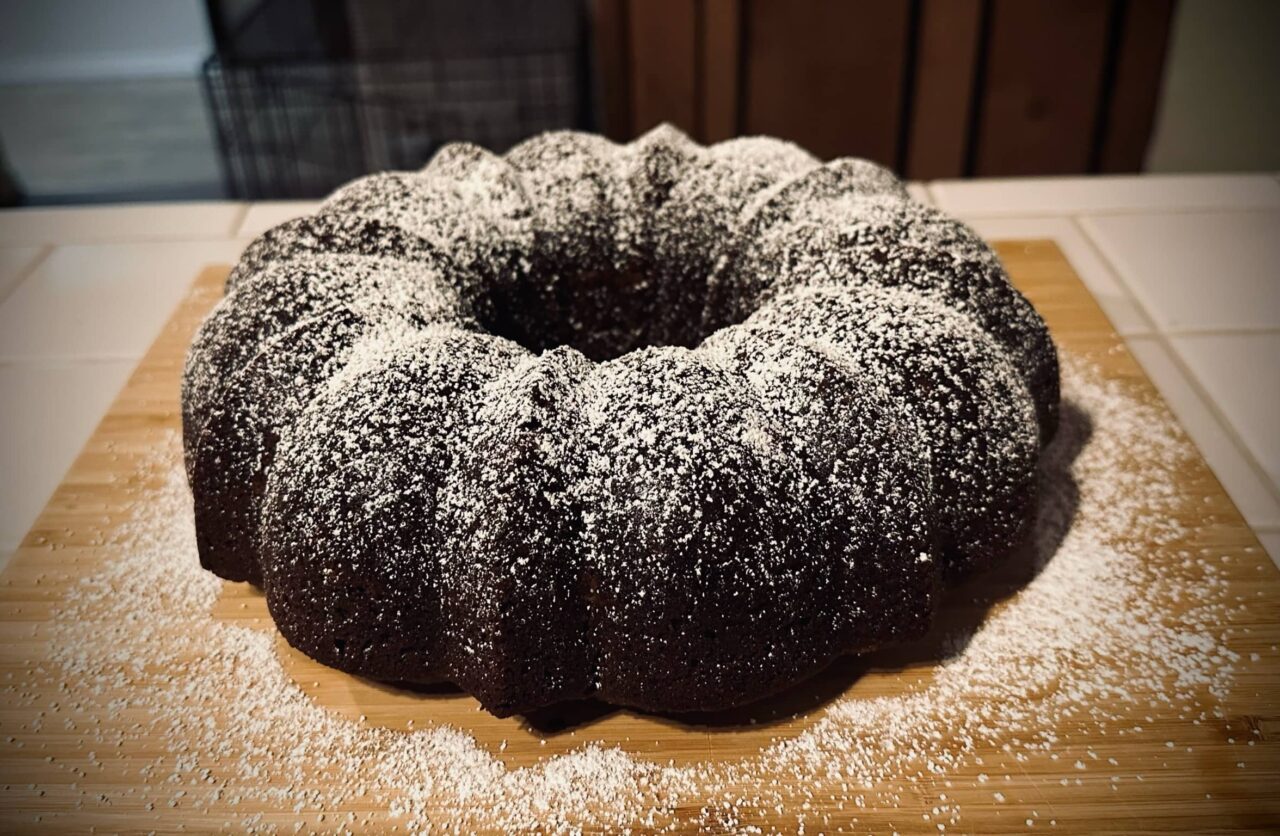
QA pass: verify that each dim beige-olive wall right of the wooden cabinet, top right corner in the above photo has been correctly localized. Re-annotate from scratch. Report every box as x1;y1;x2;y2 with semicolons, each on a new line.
1147;0;1280;172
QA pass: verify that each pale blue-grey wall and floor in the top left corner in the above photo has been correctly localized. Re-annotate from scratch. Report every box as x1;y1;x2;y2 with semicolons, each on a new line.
0;0;223;204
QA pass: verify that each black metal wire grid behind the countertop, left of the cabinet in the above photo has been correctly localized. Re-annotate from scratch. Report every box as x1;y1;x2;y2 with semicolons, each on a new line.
202;45;588;200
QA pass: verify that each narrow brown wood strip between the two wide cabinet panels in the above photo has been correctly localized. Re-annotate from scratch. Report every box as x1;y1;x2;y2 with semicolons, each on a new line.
904;0;983;179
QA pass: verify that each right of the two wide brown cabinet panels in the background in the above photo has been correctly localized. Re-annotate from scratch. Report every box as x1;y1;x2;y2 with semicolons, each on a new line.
973;0;1111;177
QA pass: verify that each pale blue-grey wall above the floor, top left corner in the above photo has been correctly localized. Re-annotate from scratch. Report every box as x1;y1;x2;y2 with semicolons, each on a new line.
0;0;212;84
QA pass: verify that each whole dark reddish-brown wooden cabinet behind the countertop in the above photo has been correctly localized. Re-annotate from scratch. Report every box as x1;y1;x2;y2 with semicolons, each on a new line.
593;0;1174;178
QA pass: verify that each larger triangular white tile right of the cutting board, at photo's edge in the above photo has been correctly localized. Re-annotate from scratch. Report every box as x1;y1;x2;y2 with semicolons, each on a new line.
1170;332;1280;490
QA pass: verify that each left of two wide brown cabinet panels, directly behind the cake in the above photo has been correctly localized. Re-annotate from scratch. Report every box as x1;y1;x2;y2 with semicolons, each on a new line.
744;0;910;165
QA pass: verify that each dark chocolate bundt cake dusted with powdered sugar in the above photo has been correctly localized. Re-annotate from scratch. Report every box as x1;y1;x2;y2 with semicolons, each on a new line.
183;127;1059;716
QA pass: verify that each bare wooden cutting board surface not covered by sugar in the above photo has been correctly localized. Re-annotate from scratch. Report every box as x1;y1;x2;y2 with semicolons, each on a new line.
0;241;1280;832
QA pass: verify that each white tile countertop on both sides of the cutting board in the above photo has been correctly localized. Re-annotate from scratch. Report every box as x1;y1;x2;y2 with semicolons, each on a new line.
0;174;1280;566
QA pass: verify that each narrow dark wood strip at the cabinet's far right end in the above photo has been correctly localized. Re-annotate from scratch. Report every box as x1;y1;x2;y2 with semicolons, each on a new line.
1098;0;1174;173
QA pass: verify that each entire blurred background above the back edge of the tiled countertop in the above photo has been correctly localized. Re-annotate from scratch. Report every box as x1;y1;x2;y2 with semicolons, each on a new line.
0;0;1280;204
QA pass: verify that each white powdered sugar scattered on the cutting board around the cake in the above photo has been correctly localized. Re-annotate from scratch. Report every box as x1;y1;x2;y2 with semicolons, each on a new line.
17;357;1259;832
